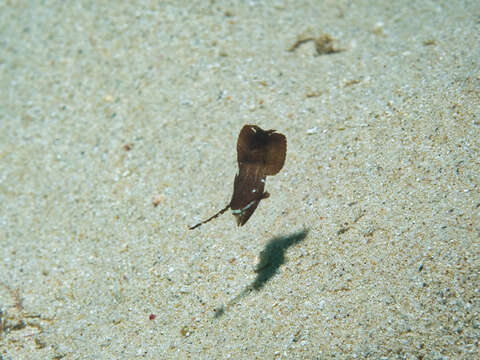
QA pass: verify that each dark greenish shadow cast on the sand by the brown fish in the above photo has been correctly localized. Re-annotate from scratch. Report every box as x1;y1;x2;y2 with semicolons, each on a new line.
215;229;308;318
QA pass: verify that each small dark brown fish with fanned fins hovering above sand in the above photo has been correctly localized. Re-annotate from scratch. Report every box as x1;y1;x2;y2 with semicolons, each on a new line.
190;125;287;230
